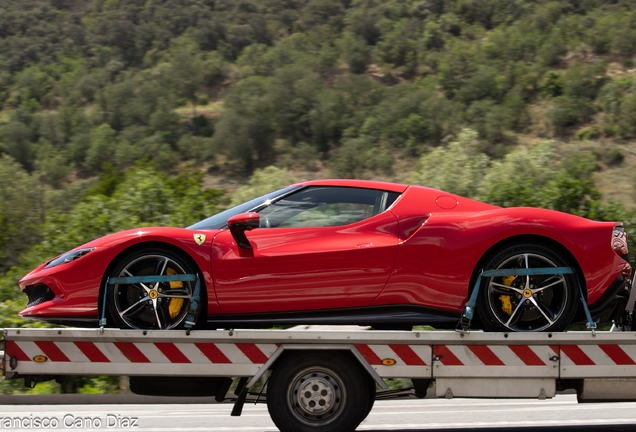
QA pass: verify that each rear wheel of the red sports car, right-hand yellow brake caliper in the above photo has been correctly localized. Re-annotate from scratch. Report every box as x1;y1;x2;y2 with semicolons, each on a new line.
477;243;579;332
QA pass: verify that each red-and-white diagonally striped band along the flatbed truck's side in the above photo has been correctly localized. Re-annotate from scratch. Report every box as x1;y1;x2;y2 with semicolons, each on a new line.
5;339;636;378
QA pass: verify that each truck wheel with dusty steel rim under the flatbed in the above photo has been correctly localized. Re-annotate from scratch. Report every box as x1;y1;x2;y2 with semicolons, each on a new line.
267;351;370;432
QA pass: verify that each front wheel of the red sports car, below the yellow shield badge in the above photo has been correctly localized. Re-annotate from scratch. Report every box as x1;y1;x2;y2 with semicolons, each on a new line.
106;248;196;330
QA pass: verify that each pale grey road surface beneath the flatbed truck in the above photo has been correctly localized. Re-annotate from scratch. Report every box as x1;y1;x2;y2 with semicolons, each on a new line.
0;395;636;432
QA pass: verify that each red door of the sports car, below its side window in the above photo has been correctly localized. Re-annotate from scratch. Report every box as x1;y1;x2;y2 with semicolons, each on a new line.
212;188;398;314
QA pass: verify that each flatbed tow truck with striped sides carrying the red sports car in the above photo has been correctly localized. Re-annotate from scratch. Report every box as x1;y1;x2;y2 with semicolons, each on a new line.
0;268;636;432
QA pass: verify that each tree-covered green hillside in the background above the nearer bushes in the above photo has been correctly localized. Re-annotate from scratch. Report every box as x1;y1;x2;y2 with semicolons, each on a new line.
6;0;636;176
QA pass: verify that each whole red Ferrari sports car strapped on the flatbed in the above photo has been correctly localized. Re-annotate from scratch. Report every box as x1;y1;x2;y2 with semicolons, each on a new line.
20;180;631;332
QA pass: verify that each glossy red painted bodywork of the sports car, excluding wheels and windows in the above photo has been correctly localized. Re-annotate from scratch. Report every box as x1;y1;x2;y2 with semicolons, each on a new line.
20;180;631;328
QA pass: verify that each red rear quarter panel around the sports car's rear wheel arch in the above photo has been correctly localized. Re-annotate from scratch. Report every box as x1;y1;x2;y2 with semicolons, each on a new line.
373;208;630;312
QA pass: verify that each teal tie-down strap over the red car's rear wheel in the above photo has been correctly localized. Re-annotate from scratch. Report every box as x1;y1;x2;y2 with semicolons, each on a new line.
458;267;596;331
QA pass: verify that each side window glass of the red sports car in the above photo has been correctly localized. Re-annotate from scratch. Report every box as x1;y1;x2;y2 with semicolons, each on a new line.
259;187;399;228
